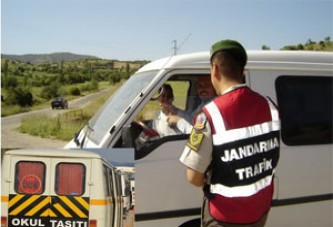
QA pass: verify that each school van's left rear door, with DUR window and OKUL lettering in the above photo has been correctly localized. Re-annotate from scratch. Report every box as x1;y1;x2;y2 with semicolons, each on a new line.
8;156;51;227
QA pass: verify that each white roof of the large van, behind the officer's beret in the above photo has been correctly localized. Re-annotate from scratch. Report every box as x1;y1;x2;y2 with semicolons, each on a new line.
139;50;333;72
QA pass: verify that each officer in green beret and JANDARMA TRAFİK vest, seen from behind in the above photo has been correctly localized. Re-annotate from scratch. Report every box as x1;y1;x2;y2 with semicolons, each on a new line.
180;40;280;226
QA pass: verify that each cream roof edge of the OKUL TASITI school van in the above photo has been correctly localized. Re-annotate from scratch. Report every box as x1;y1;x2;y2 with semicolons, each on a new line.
5;148;102;159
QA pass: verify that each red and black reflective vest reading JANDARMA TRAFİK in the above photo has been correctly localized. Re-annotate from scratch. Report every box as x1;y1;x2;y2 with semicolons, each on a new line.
203;87;280;224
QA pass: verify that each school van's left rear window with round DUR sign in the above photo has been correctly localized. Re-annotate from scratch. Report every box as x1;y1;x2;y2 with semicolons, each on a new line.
15;161;45;194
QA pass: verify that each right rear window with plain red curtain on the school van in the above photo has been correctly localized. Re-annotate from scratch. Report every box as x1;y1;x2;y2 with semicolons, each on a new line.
55;163;85;196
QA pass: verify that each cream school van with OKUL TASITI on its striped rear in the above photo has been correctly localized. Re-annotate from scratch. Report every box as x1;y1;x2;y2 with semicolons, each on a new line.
1;149;123;227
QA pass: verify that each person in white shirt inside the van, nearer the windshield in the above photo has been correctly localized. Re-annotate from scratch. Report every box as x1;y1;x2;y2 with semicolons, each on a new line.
152;84;181;137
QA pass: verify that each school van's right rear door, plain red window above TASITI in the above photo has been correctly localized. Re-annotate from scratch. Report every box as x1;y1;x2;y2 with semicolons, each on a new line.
50;158;91;226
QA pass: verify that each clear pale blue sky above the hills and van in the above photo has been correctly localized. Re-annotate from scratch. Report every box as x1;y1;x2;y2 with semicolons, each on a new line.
1;0;333;61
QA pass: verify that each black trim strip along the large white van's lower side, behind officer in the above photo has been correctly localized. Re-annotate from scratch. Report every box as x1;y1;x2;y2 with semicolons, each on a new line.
135;193;333;222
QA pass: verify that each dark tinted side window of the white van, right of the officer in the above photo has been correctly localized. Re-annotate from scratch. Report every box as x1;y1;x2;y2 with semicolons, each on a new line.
275;76;333;145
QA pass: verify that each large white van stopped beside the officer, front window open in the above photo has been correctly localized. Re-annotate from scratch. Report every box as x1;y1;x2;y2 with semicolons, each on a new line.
67;51;333;227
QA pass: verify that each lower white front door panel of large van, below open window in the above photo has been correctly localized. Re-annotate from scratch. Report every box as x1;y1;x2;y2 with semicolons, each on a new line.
135;139;202;227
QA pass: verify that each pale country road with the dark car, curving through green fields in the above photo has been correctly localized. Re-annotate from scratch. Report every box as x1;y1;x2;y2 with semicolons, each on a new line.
1;90;107;149
